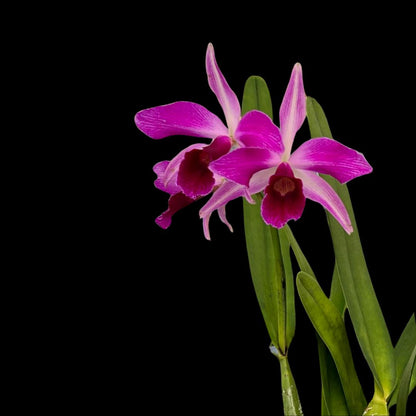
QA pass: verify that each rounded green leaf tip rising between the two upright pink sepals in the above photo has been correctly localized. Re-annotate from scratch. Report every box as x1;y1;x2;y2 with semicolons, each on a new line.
242;75;273;119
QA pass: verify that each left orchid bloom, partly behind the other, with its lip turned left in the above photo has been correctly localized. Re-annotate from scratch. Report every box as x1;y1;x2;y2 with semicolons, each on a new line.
135;44;278;239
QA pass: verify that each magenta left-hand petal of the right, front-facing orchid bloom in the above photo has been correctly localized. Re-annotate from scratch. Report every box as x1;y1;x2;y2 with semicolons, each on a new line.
210;147;279;186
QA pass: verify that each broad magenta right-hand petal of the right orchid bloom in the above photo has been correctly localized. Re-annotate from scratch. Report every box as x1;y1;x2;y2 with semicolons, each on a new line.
290;137;373;183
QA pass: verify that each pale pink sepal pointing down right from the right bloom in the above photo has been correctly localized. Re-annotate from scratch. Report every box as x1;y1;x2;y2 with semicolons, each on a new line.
294;169;353;234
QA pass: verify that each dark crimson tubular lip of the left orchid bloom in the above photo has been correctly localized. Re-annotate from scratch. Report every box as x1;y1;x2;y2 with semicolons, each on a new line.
177;136;231;198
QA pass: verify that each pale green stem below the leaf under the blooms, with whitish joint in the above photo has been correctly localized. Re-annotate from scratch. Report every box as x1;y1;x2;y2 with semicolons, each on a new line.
270;346;303;416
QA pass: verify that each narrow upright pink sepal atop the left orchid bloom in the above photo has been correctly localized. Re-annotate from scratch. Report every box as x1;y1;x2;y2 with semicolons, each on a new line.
205;43;241;134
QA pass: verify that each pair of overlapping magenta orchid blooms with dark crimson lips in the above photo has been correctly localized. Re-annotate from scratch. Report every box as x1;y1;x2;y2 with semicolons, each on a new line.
135;44;372;240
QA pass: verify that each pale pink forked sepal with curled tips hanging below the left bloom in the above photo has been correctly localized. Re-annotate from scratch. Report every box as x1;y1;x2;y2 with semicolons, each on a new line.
199;182;246;240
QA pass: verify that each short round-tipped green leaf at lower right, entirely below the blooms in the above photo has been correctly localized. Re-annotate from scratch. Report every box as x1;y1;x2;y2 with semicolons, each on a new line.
296;271;366;415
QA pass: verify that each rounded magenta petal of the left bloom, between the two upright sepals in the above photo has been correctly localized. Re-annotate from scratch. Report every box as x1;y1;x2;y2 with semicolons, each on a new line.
234;110;284;154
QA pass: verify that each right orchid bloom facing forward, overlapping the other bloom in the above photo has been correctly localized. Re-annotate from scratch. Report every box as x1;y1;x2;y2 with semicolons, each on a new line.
210;63;372;234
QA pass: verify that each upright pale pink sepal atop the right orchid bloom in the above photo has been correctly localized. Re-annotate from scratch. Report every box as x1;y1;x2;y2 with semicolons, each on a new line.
279;63;306;160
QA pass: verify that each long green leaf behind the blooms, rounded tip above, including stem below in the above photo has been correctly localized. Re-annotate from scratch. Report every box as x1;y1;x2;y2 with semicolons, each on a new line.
242;76;303;416
